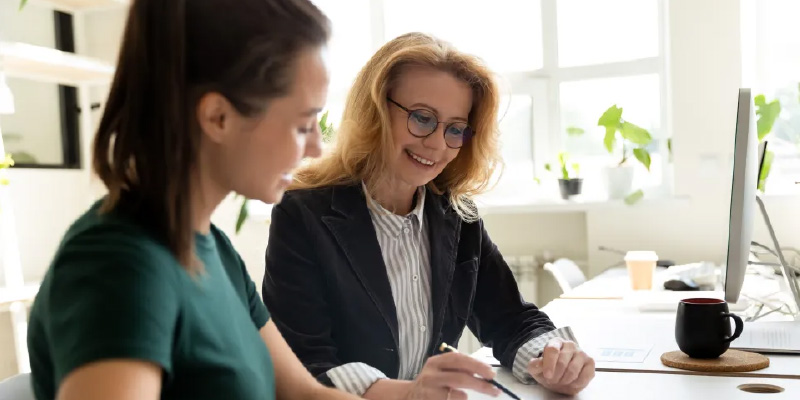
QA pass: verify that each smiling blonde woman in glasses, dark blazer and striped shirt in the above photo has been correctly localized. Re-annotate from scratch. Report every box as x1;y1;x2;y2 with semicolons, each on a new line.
263;33;594;400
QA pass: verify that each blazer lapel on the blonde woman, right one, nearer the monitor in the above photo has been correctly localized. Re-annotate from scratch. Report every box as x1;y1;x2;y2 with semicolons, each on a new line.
425;189;461;355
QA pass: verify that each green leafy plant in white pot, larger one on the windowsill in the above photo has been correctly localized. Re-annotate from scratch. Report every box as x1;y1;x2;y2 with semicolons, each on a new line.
597;104;653;200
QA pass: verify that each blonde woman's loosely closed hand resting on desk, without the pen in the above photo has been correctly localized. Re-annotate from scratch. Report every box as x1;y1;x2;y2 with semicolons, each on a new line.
528;338;594;396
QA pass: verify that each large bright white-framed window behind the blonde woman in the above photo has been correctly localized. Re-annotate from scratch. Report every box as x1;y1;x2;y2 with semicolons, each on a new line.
306;0;668;197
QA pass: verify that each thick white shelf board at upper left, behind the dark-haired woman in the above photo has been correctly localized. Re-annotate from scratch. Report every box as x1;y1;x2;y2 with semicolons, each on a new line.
0;42;114;86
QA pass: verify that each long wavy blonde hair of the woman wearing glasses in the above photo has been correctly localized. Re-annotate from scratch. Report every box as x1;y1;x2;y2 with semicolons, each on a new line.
290;33;502;221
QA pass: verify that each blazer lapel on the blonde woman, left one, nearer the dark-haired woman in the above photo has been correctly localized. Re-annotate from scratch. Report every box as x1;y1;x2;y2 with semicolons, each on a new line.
322;185;400;348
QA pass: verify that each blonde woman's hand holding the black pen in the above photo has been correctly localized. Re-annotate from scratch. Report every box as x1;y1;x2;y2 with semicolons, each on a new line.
405;353;501;400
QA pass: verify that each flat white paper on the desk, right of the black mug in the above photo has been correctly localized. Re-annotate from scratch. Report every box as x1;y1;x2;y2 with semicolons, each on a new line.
731;321;800;354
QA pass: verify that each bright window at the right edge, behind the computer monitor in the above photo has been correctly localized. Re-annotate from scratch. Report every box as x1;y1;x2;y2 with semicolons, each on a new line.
741;0;800;194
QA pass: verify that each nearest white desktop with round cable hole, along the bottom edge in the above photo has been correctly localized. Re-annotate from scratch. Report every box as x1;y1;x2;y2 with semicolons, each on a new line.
469;371;800;400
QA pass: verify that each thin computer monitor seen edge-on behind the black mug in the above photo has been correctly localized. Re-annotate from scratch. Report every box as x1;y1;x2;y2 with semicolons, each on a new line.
724;89;763;303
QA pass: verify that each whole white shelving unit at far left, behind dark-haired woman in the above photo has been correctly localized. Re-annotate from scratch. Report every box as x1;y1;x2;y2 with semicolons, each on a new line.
0;0;122;372
